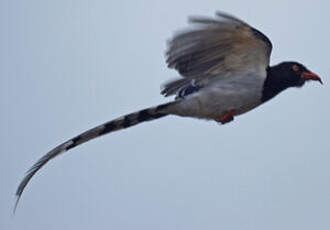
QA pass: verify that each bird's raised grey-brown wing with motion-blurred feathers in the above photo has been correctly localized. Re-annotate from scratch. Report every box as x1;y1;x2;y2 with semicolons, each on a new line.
163;12;272;95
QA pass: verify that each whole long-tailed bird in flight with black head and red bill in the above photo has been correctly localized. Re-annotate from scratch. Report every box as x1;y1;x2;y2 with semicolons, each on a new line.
14;12;323;212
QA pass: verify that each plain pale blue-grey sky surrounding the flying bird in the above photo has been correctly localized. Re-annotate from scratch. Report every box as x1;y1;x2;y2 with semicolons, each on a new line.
0;0;330;230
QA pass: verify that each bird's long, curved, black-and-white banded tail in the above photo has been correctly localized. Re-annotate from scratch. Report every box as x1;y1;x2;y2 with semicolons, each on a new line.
14;102;175;213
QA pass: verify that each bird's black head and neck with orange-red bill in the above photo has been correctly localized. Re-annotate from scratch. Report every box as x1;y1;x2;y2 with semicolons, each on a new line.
262;62;323;102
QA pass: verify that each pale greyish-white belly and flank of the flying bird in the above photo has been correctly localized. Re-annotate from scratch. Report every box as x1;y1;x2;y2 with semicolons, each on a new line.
169;74;265;120
